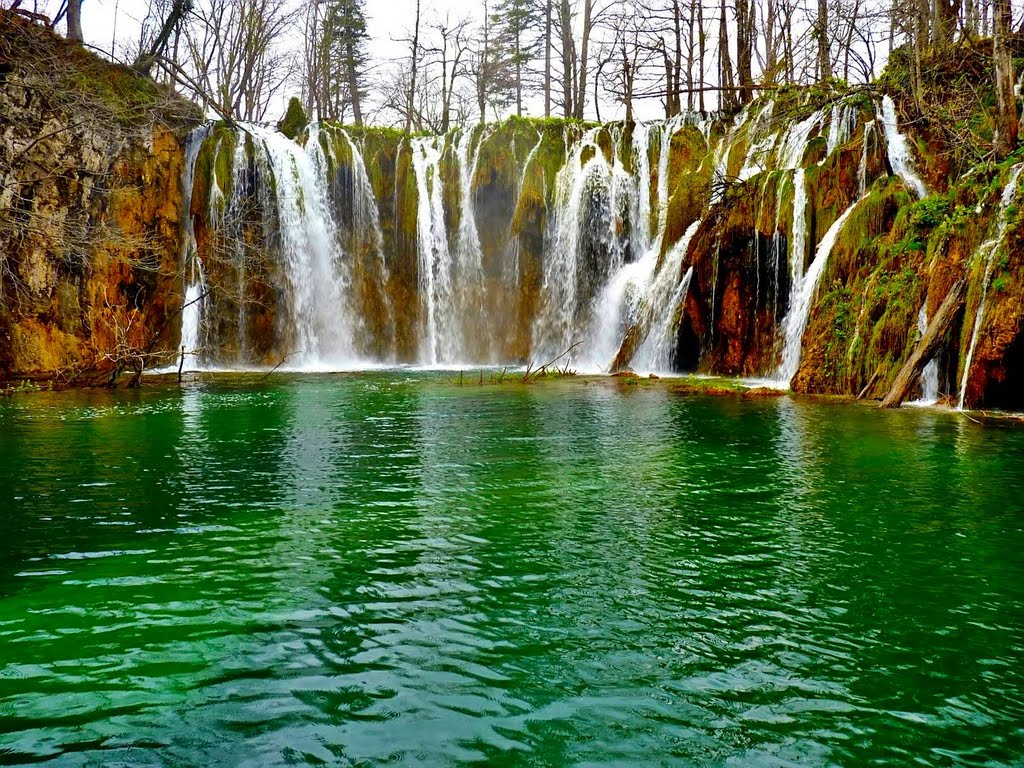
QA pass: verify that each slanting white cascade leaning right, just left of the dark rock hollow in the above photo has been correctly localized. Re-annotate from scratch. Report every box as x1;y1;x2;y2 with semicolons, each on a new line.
632;219;700;371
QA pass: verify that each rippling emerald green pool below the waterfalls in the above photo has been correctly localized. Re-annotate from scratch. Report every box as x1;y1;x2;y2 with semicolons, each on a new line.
0;372;1024;766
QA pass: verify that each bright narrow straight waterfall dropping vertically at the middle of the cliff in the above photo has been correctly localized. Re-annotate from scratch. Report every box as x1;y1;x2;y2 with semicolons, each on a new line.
412;138;456;365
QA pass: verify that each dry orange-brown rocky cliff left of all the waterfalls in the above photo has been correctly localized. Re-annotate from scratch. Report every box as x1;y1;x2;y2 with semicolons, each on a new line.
0;13;197;380
